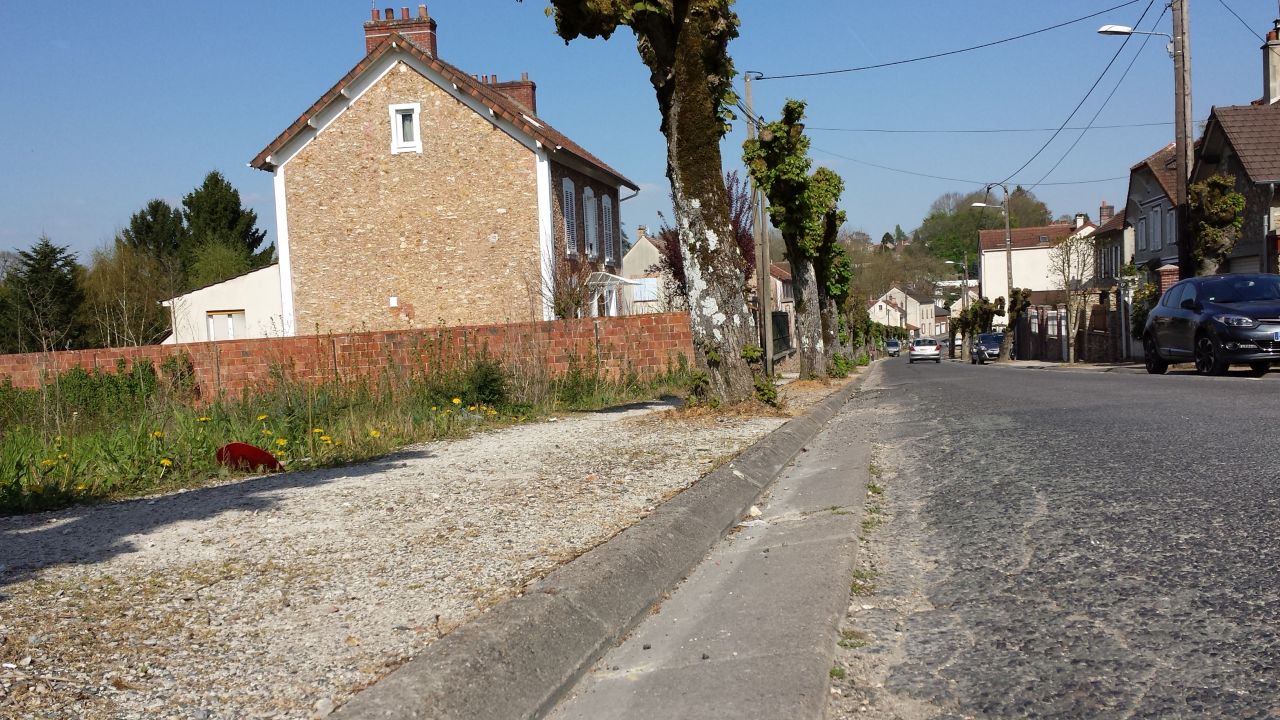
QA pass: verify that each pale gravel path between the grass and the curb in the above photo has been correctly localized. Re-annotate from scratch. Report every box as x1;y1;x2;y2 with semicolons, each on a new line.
0;383;835;719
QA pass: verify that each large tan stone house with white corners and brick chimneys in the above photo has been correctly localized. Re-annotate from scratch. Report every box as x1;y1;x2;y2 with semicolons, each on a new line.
251;5;637;334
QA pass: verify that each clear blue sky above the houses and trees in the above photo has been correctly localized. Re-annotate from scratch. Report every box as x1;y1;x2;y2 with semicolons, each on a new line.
0;0;1277;261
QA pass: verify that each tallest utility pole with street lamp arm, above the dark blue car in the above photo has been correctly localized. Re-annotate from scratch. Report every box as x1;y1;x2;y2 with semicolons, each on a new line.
1098;0;1196;278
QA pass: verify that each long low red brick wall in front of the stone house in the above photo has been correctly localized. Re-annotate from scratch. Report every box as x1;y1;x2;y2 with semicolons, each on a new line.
0;313;694;400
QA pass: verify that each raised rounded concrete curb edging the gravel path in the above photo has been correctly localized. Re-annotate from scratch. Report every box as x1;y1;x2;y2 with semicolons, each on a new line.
330;372;867;720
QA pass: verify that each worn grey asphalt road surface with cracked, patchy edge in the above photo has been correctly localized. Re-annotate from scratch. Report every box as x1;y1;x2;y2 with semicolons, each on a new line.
828;359;1280;719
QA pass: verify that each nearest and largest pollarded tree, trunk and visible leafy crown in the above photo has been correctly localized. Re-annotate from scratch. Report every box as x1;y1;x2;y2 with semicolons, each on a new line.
529;0;756;401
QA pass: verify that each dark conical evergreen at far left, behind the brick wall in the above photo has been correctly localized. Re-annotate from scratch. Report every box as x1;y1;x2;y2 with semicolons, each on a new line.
0;236;84;352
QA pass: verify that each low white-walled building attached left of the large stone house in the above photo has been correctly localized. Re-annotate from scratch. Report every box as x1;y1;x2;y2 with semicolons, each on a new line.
164;264;284;345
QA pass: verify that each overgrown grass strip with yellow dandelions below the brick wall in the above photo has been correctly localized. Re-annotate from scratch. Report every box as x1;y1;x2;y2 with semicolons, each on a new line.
0;348;689;515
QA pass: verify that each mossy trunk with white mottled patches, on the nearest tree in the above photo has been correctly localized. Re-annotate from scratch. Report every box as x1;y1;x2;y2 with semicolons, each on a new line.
641;13;759;402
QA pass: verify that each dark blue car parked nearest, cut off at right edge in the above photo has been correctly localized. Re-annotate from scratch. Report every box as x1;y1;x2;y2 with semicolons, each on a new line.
1142;274;1280;375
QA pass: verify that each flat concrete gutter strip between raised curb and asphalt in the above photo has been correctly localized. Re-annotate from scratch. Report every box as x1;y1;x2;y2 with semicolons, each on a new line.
548;379;869;720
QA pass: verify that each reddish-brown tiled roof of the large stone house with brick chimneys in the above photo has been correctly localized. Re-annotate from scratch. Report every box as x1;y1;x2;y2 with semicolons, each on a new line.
250;33;640;190
